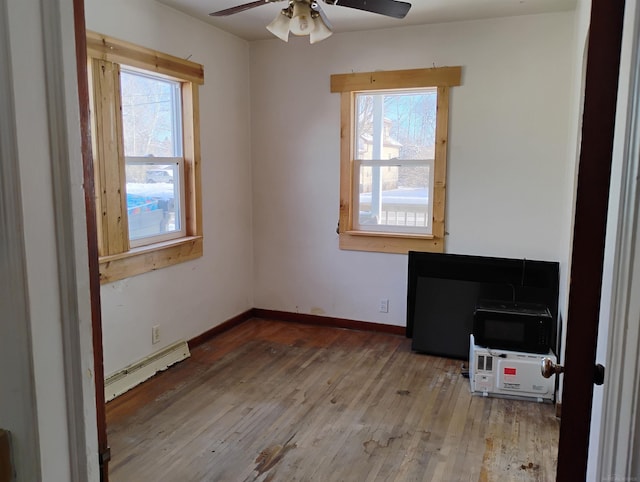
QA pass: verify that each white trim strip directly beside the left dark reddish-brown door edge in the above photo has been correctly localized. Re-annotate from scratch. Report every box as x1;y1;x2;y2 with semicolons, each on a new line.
40;0;98;482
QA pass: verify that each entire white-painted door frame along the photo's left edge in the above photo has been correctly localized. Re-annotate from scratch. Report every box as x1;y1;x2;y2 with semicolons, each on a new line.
0;0;97;482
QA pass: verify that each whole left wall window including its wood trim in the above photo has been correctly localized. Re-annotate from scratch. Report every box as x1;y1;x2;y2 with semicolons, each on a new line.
87;32;204;282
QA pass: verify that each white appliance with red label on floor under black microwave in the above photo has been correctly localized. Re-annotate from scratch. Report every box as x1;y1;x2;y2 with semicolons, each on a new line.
469;335;557;402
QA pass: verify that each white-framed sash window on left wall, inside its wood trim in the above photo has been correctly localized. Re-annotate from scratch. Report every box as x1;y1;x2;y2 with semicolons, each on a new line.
120;67;185;247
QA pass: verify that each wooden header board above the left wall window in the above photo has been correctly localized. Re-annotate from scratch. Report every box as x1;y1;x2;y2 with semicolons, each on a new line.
87;31;204;85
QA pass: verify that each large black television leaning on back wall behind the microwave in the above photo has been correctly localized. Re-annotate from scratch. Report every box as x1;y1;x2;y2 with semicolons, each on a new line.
406;251;560;360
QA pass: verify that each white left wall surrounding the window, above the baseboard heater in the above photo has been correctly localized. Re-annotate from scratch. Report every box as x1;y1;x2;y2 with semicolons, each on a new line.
85;0;254;375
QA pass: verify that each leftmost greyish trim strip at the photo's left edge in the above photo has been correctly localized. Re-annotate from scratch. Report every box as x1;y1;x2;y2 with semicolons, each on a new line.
0;0;43;482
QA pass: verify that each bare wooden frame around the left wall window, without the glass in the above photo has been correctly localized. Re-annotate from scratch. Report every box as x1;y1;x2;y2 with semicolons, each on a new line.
87;31;204;283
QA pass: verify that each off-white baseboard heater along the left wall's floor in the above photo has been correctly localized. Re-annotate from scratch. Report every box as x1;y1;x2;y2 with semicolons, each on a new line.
104;341;191;402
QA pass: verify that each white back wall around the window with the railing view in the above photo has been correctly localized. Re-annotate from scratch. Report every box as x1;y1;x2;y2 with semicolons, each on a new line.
251;12;575;325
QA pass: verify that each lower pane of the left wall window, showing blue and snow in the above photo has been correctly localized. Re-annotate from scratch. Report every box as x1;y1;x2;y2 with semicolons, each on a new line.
126;160;182;246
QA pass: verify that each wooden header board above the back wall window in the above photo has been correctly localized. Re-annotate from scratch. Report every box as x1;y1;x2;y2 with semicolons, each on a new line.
331;66;462;92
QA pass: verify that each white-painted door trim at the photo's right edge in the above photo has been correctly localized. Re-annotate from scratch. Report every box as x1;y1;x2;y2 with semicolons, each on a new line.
597;2;640;481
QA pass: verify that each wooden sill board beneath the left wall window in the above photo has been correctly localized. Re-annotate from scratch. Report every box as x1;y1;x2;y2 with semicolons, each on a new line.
99;236;203;284
